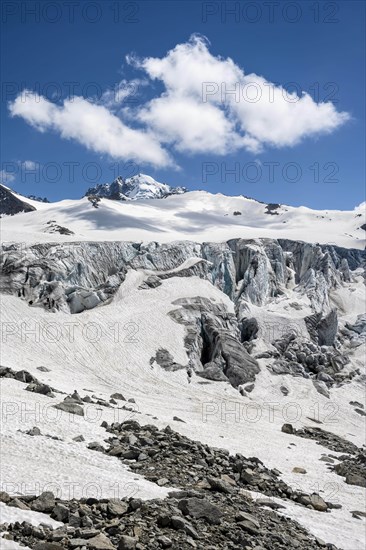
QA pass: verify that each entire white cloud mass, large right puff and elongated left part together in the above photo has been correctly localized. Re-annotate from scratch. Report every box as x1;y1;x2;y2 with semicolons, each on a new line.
9;35;350;167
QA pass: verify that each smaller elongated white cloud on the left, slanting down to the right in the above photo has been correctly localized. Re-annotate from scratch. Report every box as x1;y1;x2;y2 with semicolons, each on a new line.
9;90;172;166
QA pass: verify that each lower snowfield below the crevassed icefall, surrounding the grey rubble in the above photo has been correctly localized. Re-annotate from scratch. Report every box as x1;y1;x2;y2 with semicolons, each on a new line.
2;270;365;550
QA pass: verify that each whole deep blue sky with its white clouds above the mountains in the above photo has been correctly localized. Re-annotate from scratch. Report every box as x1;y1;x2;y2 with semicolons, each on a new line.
1;0;365;209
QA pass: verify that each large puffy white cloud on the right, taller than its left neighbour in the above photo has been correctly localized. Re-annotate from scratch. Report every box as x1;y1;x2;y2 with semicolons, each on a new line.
133;36;349;154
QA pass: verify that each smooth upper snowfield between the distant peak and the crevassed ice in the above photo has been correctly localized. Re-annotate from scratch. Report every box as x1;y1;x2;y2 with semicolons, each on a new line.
1;184;366;249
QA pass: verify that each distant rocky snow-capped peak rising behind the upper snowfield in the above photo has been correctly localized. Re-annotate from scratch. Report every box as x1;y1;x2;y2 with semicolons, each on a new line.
85;174;187;201
